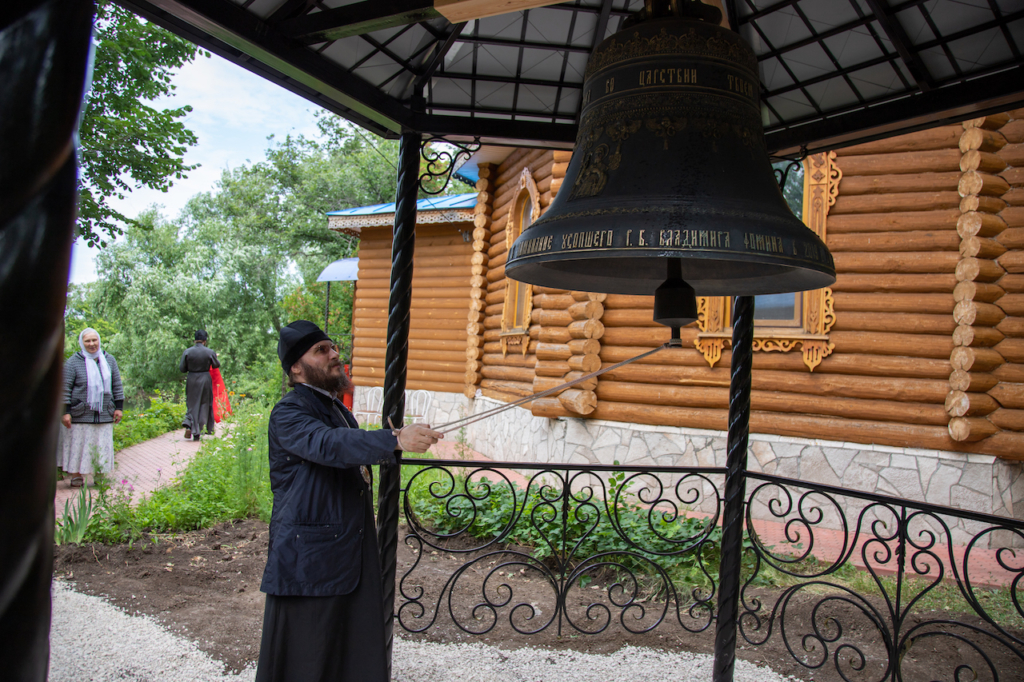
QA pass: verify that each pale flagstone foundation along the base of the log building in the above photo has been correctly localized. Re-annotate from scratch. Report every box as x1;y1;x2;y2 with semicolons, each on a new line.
356;388;1024;546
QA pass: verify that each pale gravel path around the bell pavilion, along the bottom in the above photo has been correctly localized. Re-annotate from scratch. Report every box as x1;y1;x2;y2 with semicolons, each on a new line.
49;583;793;682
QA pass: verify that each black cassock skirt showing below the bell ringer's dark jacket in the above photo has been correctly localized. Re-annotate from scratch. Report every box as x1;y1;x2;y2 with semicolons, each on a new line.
256;504;387;682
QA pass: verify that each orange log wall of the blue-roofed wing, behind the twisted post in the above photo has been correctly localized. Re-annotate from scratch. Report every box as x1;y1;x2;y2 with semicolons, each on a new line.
352;222;473;393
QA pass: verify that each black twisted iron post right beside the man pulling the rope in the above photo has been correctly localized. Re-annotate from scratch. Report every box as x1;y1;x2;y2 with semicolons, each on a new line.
377;132;420;677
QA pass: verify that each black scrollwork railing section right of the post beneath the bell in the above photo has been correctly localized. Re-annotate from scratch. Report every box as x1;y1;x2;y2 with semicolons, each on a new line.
739;474;1024;682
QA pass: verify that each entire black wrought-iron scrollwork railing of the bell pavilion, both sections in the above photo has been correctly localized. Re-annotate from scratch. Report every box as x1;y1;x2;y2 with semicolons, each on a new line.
395;460;1024;682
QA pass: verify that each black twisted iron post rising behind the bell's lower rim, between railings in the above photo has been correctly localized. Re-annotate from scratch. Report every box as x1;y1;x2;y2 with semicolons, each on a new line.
712;296;754;682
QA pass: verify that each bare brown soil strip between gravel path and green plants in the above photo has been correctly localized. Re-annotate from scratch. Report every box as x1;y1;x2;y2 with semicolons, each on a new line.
54;520;1024;682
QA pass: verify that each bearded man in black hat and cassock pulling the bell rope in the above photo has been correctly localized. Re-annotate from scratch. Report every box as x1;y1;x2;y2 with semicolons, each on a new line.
256;319;441;682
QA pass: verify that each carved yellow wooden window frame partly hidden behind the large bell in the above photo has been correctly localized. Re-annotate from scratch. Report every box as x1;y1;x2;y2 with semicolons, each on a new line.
694;152;843;372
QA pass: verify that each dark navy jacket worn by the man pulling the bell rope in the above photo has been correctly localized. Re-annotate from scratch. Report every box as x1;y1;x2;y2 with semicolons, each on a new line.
260;385;398;597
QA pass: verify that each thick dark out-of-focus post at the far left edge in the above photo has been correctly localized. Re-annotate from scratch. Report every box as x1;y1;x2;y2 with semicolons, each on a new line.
0;0;93;682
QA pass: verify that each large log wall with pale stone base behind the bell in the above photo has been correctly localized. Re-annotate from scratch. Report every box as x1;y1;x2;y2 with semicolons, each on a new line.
460;118;1024;538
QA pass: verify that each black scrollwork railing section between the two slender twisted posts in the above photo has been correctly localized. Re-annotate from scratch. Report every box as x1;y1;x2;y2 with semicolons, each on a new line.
397;461;721;636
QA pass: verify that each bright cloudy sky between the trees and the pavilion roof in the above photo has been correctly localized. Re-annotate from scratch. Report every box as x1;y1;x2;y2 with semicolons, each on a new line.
71;54;316;284
